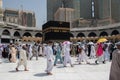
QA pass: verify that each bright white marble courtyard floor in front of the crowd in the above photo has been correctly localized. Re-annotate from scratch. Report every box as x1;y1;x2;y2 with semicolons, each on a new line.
0;57;111;80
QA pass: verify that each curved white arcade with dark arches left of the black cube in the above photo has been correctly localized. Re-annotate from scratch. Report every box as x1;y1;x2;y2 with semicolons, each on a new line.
0;22;42;44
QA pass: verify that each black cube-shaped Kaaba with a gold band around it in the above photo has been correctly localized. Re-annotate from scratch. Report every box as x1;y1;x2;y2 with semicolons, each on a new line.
42;21;72;41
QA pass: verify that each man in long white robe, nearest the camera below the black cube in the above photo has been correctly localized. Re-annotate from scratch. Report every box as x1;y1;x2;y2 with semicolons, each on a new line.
46;41;54;75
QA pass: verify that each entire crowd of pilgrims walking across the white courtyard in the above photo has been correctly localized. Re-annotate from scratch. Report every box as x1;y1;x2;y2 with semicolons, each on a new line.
0;41;120;80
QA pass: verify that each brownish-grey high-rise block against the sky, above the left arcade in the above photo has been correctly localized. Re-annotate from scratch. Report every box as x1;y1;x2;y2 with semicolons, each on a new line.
3;9;36;27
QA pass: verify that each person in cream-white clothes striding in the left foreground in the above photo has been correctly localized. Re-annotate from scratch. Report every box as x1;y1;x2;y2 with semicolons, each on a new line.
16;44;28;71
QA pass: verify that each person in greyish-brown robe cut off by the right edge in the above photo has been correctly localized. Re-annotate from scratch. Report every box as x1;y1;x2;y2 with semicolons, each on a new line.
109;41;120;80
